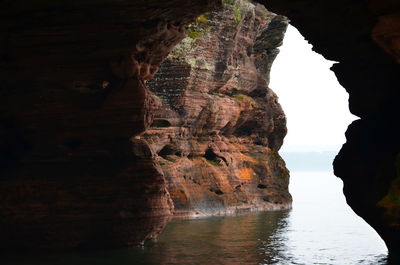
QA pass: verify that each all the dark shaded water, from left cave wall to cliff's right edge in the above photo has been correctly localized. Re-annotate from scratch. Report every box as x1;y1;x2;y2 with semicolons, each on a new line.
4;212;288;265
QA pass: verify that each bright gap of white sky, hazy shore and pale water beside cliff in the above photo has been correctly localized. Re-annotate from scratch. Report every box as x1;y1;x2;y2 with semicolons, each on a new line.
270;26;387;264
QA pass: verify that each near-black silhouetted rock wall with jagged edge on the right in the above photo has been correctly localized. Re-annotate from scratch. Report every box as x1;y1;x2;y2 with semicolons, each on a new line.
259;0;400;255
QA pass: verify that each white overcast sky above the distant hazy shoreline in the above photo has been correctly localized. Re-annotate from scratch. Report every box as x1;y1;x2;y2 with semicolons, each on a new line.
269;26;357;151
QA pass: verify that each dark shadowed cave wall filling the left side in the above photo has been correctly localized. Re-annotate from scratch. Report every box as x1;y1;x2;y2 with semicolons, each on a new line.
0;0;220;250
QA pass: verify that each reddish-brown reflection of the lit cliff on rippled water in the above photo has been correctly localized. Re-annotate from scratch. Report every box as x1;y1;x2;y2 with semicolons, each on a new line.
142;209;288;265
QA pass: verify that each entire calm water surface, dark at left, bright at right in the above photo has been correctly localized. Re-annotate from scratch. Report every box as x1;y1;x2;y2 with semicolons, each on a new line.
2;172;387;265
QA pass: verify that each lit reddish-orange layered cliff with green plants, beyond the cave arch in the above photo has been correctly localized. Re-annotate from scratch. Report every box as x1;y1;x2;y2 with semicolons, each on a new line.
141;1;291;215
